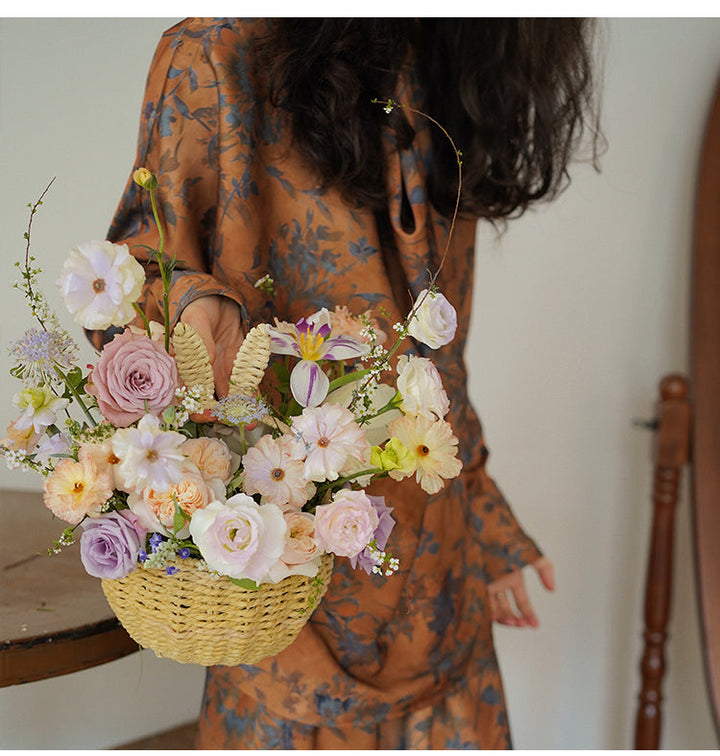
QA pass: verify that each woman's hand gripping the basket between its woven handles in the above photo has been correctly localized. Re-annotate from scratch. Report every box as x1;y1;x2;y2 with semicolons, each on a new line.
180;296;245;398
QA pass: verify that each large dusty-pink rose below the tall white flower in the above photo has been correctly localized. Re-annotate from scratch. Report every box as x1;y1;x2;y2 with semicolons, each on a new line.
87;330;178;428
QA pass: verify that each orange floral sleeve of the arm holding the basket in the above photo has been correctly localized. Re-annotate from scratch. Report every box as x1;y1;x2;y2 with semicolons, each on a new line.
100;20;258;340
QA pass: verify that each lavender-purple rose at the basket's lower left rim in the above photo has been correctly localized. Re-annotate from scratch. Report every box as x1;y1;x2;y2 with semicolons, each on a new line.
80;511;147;579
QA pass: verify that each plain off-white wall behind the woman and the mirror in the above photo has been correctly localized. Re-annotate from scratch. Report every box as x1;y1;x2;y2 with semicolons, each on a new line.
0;19;720;749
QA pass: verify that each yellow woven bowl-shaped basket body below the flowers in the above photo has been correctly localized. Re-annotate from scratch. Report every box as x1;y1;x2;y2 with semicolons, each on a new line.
102;554;333;666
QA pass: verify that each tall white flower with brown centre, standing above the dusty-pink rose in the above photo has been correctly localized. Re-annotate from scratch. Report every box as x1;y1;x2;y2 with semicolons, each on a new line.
57;241;145;330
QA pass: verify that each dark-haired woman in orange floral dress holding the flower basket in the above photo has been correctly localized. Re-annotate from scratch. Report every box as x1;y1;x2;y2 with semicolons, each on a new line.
109;19;592;749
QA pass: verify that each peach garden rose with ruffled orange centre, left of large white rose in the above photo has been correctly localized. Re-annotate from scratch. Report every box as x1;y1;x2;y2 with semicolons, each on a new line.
128;469;225;538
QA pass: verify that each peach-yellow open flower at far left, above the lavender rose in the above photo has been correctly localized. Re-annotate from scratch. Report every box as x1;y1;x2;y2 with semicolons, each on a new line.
43;459;113;525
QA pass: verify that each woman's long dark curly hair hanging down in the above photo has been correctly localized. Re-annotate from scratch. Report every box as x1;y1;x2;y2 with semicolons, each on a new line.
258;18;599;220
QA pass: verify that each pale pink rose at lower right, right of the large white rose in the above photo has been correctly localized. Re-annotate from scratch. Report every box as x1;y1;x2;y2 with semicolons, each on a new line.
315;489;378;557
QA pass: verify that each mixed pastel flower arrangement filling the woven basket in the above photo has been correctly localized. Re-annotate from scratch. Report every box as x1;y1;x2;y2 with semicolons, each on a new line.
0;102;461;663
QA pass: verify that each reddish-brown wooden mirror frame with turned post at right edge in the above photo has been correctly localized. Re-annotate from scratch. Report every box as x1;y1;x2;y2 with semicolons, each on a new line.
635;75;720;750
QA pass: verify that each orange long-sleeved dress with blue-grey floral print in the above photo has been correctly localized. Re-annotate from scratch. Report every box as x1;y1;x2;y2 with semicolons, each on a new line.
109;19;540;749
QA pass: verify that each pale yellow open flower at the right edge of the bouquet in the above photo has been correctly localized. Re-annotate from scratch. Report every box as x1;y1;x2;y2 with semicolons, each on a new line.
388;415;462;494
